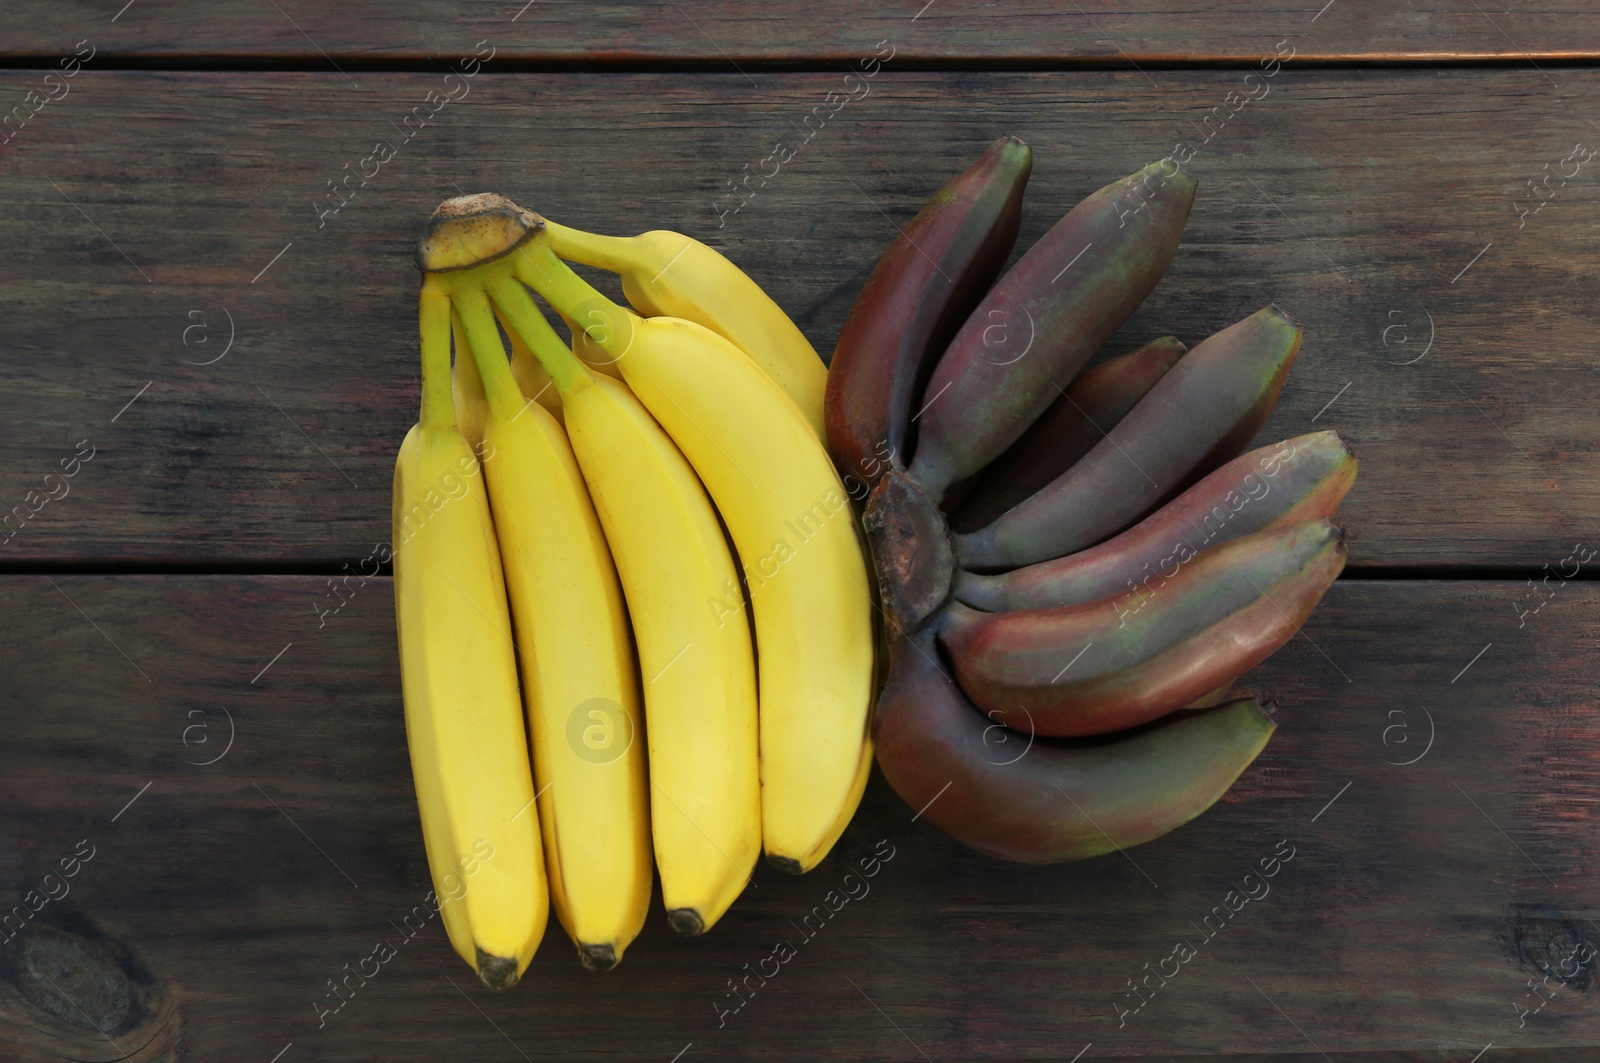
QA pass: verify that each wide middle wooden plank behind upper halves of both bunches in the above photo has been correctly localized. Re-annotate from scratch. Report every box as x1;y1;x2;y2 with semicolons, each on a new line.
0;64;1600;570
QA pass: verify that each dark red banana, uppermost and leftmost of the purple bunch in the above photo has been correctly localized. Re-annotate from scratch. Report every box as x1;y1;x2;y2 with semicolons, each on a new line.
824;136;1034;493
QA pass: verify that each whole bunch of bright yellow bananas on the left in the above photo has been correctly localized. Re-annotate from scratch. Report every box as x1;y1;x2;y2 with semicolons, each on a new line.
394;195;874;988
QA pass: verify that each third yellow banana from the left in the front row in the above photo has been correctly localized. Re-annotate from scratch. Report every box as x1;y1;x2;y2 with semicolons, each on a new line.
469;274;762;935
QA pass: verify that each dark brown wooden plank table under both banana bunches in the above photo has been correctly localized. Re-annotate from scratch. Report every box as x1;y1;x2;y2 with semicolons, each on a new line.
0;0;1600;1063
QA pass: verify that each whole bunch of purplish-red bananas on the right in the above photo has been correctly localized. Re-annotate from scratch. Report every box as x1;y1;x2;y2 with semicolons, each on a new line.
826;138;1355;863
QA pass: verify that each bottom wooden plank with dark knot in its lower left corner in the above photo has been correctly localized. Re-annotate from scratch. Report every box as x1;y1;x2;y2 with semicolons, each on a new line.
0;576;1600;1063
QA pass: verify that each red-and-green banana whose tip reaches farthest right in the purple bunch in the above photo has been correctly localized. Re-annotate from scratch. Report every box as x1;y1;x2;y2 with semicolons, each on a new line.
955;431;1357;613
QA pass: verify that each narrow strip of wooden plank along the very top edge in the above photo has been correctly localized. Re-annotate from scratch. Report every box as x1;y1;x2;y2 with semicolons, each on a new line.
0;0;1600;69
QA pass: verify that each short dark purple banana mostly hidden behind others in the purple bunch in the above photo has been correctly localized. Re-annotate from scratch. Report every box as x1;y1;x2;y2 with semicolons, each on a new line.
950;336;1189;532
